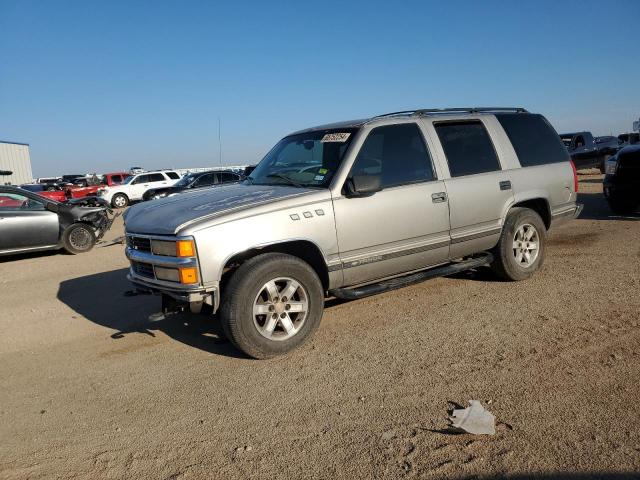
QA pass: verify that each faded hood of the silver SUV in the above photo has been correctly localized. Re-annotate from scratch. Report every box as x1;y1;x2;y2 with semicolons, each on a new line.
124;183;317;235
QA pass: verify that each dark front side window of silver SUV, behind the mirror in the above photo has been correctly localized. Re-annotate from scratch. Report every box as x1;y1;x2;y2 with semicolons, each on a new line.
350;123;435;188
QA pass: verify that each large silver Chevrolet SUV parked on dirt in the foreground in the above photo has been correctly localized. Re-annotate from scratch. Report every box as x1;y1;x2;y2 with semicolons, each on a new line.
125;108;581;358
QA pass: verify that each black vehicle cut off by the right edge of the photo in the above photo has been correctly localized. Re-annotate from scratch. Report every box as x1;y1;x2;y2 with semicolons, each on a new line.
603;144;640;214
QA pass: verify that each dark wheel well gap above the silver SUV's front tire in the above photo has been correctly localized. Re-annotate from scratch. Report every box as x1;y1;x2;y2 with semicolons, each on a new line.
221;240;329;290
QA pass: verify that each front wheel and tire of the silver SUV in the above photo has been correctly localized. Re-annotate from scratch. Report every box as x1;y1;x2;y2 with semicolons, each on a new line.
220;253;324;359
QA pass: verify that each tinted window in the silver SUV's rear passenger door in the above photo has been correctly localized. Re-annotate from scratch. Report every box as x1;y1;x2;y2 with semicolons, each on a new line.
434;120;501;177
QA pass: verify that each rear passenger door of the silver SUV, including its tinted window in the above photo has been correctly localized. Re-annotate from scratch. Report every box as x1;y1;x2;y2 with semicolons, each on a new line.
430;119;513;258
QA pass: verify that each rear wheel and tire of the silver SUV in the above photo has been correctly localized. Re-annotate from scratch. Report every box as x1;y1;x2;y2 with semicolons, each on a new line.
491;207;547;281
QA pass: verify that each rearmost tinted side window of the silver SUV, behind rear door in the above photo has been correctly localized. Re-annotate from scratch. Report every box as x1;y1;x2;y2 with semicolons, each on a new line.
496;113;568;167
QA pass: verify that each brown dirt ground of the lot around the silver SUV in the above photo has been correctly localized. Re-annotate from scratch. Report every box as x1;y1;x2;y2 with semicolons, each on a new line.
0;175;640;479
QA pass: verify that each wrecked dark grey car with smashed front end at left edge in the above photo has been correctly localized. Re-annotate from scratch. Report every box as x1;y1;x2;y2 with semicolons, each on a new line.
0;186;115;255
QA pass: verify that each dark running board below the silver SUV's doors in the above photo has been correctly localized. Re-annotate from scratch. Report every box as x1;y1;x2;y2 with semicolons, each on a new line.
329;252;493;300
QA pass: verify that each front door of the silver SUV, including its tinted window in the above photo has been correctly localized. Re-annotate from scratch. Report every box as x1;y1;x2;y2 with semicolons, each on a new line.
334;123;450;285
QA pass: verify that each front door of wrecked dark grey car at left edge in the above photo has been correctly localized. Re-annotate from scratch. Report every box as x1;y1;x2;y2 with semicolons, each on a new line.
0;192;60;250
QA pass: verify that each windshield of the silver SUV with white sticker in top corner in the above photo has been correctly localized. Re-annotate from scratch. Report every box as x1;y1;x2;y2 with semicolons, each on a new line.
247;128;357;188
